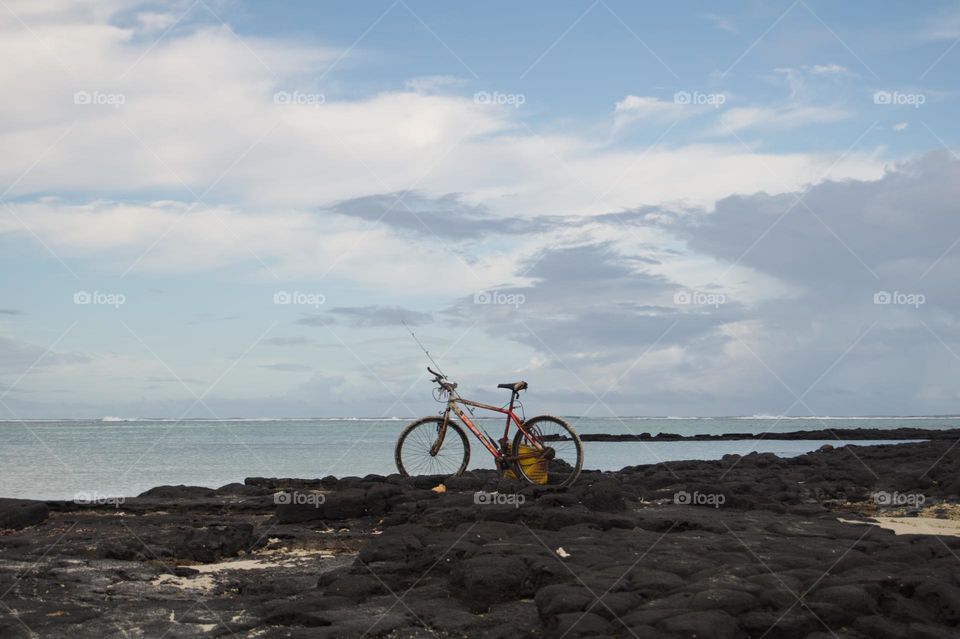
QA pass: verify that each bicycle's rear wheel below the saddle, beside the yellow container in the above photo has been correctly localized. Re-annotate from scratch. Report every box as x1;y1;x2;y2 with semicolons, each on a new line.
511;415;583;486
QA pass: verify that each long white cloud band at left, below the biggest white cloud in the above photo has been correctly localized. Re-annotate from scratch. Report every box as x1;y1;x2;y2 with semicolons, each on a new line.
0;200;515;295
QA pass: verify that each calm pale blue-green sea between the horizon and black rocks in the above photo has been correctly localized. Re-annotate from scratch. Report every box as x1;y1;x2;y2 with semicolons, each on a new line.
0;416;960;499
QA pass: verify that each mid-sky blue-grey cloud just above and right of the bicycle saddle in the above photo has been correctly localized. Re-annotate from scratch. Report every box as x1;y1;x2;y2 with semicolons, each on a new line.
446;242;734;358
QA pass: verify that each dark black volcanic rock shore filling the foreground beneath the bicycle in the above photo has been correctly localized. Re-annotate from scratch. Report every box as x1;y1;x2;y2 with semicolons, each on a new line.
0;440;960;639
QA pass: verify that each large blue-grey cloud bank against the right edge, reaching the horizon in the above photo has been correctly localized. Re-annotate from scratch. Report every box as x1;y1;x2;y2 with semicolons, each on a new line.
644;152;960;414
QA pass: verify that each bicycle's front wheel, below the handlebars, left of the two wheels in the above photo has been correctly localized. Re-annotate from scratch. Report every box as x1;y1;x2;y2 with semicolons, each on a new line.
394;417;470;477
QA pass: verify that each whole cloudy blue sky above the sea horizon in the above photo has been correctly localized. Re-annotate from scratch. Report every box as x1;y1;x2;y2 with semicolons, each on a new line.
0;0;960;420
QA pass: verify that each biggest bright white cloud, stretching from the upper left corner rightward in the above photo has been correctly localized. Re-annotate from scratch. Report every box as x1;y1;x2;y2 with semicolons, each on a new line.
0;5;880;225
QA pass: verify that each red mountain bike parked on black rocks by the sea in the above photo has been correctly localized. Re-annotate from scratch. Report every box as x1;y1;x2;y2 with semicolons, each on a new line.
395;366;583;486
